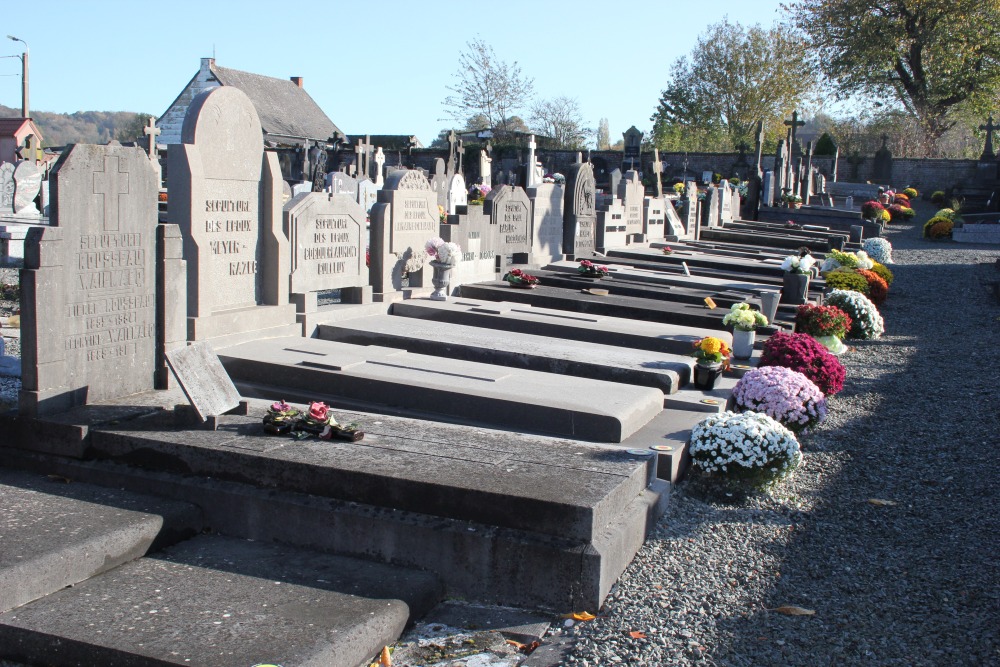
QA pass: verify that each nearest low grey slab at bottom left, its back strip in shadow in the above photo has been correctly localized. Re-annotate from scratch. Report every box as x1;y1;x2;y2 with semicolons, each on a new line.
0;536;442;667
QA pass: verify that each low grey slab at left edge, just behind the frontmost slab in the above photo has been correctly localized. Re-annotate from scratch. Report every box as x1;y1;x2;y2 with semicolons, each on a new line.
0;468;201;612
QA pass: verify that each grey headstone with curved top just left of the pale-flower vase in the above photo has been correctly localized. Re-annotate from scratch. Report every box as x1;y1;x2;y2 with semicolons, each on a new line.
370;170;444;301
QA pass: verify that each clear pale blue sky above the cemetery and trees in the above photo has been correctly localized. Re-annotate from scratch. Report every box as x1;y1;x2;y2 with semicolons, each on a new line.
0;0;781;144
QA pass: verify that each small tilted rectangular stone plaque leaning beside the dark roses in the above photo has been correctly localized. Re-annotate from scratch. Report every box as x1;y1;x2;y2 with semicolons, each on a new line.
167;342;240;421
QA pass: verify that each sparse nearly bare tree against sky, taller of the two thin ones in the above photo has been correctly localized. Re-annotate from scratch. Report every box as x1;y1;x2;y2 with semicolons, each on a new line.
443;38;534;137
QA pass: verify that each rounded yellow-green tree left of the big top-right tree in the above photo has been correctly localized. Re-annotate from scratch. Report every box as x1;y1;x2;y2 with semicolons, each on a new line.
650;19;817;150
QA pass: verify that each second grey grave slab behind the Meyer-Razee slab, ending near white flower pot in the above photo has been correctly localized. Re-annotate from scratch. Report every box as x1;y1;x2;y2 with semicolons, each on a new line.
392;298;732;355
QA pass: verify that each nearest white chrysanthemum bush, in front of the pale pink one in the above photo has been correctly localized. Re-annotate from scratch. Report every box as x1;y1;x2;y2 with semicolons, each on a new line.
690;411;802;490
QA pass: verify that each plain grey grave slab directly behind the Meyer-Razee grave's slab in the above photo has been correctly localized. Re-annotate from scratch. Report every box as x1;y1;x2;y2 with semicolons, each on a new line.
317;315;694;394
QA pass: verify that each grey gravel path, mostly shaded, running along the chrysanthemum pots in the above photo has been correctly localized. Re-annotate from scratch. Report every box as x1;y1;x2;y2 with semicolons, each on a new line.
566;217;1000;666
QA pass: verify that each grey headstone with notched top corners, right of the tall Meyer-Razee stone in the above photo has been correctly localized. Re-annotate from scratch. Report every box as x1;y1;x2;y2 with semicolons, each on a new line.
283;192;371;320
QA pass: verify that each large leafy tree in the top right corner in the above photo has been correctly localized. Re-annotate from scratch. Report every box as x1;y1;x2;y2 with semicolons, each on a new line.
785;0;1000;156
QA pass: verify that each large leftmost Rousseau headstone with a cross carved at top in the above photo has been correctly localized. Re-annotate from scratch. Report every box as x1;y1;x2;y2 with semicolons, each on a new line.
19;142;159;416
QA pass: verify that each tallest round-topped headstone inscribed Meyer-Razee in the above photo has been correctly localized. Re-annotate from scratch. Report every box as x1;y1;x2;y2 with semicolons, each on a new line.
168;86;297;344
